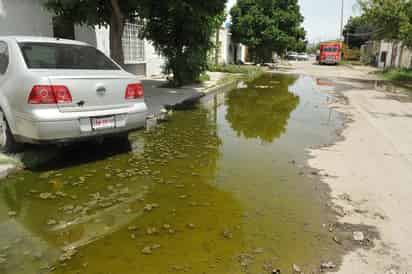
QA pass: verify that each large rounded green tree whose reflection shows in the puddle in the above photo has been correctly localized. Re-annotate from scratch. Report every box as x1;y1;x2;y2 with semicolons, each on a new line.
230;0;306;63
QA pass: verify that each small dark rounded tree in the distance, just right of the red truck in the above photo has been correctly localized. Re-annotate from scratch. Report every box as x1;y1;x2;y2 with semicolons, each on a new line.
343;16;375;49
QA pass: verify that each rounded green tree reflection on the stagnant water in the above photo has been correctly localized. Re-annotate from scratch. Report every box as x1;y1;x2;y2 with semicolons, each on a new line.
226;75;299;143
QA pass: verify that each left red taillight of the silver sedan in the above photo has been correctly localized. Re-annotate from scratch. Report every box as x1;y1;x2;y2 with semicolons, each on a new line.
28;85;72;104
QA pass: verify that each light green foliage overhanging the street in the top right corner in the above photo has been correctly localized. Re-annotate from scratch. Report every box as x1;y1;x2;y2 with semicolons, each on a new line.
359;0;412;46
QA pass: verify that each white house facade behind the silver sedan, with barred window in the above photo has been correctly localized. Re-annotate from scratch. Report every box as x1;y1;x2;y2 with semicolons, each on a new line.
0;0;164;77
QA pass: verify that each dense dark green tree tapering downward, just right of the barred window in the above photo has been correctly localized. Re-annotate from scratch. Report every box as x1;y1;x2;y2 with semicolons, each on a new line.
141;0;226;86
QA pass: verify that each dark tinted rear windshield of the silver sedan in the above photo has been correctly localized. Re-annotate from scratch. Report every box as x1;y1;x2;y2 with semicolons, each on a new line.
19;42;119;70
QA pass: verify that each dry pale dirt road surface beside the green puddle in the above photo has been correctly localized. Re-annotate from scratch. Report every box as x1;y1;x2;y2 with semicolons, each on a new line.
289;63;412;274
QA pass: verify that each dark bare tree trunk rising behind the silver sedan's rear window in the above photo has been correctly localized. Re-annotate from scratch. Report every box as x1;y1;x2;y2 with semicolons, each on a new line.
110;0;125;66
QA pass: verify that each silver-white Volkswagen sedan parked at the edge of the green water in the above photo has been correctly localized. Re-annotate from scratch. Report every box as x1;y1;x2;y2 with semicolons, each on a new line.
0;36;147;151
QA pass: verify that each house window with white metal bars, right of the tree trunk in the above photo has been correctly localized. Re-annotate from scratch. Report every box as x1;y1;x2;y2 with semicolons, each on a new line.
122;23;145;64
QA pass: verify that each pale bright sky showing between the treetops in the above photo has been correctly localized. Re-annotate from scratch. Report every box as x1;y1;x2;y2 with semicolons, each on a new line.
228;0;360;42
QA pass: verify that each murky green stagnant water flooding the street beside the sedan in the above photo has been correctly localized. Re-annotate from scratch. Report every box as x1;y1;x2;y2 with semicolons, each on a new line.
0;75;342;274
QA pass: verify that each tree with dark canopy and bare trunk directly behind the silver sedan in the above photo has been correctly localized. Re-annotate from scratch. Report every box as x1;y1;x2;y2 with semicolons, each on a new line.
45;0;140;65
